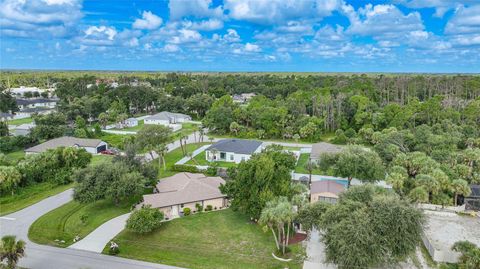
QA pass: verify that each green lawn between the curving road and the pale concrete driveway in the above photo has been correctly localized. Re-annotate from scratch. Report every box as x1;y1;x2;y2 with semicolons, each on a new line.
28;194;140;247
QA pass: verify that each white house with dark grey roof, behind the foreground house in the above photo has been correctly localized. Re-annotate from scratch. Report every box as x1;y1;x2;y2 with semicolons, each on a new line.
205;139;262;163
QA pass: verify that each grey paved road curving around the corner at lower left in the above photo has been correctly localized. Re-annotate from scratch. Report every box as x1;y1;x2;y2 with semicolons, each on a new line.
0;189;183;269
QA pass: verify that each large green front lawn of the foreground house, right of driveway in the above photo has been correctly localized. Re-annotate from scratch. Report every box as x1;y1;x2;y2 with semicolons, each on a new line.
108;209;303;269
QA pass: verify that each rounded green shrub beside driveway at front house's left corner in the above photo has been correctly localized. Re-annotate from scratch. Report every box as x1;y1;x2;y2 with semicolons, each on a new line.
126;206;163;233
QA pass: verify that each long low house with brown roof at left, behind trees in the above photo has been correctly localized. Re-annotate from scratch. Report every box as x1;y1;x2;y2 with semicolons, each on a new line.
25;136;108;154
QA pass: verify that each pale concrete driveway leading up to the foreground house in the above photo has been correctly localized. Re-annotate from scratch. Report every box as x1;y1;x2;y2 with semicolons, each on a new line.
68;213;131;253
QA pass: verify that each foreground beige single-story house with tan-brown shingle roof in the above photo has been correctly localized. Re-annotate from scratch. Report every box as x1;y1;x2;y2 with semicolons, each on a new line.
142;173;228;219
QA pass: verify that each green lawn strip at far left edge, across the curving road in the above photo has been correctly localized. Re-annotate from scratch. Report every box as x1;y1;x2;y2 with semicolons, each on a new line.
0;182;73;216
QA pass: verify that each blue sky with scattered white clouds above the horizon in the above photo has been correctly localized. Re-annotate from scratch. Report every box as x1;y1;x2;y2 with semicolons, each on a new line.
0;0;480;73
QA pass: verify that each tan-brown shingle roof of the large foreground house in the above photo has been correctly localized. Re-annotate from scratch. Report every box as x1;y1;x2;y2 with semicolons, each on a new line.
143;173;226;208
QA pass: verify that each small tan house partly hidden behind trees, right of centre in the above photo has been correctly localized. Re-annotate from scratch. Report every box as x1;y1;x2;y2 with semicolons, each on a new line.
310;180;345;204
